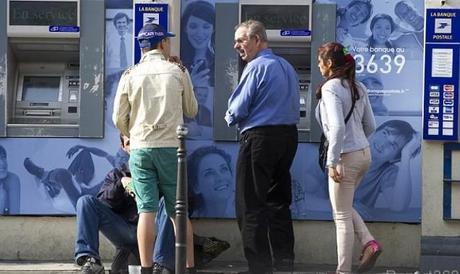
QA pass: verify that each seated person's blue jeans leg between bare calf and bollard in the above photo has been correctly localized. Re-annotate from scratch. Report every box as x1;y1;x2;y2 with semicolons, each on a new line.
153;198;176;270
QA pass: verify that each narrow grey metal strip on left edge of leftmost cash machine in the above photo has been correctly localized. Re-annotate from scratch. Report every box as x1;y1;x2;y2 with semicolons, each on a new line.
0;1;8;137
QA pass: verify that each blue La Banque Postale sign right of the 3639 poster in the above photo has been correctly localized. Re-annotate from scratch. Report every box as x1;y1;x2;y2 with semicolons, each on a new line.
423;7;460;141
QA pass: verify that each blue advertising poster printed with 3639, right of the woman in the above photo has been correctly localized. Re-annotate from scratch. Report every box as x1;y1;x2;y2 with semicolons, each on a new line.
317;0;424;222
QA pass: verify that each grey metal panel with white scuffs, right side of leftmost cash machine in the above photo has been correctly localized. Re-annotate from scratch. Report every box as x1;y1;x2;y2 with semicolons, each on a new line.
79;0;105;138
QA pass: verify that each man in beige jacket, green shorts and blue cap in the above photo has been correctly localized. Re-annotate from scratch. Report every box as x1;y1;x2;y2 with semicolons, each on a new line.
112;24;198;274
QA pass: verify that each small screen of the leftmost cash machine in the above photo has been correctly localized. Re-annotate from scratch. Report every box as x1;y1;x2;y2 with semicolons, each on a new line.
22;76;61;103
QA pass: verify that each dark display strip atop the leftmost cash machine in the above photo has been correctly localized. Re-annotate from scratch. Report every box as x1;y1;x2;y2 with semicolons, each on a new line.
9;1;78;26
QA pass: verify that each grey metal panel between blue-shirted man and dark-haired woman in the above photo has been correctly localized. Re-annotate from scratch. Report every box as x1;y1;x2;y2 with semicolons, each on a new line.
309;4;337;142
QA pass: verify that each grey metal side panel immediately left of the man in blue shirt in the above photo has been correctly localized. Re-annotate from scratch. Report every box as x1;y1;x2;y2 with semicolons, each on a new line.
213;3;238;141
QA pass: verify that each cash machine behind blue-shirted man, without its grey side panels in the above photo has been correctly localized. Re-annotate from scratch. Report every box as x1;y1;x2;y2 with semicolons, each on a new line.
239;0;312;140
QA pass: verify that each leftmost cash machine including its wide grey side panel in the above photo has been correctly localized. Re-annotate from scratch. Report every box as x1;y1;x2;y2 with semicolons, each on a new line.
0;0;105;137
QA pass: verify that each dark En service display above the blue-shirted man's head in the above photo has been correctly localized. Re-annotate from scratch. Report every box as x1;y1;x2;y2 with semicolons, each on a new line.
241;5;310;29
